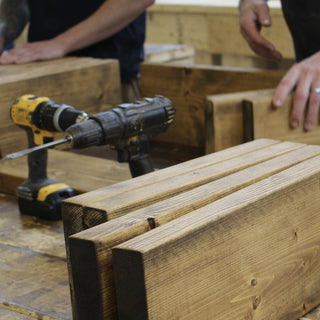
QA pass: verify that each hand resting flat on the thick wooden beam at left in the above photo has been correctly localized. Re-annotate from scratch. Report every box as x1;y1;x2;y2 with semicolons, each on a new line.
0;40;66;64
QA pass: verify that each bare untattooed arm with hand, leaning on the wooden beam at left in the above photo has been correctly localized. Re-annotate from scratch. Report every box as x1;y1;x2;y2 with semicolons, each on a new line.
0;0;154;64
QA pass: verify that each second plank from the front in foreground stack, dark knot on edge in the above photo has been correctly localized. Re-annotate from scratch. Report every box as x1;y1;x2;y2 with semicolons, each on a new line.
69;146;320;320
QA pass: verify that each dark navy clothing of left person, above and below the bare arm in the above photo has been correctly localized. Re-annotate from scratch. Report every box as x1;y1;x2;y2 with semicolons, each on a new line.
28;0;146;80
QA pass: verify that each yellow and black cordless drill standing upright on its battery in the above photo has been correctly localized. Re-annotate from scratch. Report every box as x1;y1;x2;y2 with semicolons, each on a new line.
10;95;88;220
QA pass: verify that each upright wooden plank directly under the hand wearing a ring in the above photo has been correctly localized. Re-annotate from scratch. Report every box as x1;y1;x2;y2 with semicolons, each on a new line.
243;90;320;144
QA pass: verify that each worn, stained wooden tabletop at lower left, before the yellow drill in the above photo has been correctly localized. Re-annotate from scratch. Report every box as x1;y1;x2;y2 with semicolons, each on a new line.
0;194;71;320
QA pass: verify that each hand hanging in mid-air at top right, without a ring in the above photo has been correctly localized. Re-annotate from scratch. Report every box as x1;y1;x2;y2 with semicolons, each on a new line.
239;0;282;61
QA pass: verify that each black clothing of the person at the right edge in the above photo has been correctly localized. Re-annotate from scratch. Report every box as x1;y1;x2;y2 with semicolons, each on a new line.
281;0;320;61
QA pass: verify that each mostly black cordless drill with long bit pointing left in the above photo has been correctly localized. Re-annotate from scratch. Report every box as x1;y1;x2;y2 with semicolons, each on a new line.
4;95;175;177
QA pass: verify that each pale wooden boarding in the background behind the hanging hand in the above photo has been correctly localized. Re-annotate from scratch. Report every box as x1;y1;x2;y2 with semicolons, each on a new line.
146;0;294;63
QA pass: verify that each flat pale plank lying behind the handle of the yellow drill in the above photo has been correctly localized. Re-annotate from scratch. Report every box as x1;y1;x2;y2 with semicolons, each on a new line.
0;150;131;194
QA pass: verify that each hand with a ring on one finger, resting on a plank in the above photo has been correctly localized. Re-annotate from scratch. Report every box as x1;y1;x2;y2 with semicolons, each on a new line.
273;52;320;131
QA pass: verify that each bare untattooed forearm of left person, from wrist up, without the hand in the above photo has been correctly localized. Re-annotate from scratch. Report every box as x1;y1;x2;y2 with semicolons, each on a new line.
54;0;154;54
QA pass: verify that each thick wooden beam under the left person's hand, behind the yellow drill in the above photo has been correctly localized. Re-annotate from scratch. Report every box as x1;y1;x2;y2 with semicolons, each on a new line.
0;57;121;155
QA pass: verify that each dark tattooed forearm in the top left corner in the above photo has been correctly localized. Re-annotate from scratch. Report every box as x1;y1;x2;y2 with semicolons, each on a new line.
0;0;29;47
